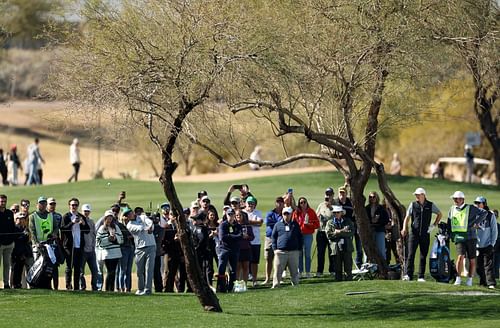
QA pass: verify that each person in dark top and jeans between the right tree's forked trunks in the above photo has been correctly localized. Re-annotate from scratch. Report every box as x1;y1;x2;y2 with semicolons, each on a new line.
365;191;389;260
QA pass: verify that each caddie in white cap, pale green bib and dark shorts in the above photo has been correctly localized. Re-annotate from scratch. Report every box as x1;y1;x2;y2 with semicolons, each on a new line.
448;190;488;286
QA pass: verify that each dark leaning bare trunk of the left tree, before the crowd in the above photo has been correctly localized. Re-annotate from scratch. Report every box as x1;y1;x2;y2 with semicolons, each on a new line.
160;153;222;312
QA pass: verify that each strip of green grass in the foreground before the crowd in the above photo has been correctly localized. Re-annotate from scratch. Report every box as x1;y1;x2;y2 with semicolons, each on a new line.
0;279;500;328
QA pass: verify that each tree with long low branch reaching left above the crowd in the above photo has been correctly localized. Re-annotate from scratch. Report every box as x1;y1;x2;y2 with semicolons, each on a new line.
194;1;434;272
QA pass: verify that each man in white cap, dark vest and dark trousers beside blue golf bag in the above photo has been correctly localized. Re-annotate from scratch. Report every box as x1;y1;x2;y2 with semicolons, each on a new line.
401;188;443;282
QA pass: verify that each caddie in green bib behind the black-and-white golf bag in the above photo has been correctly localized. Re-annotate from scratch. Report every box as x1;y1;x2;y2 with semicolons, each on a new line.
28;196;59;289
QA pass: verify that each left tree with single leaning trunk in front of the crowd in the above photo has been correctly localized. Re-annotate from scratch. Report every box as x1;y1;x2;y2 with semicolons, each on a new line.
49;0;260;311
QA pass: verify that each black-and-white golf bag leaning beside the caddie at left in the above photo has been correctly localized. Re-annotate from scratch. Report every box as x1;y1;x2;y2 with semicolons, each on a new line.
26;243;57;288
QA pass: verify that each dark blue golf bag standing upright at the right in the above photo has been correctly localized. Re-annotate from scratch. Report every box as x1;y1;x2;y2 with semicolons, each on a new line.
429;223;457;283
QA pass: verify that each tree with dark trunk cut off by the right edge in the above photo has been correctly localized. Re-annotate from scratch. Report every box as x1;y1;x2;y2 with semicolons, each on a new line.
420;0;500;185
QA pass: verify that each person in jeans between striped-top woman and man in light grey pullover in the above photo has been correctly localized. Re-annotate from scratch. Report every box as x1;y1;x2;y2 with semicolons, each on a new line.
116;207;135;293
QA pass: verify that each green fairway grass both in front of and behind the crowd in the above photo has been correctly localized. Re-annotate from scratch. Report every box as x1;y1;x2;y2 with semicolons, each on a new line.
0;172;500;328
